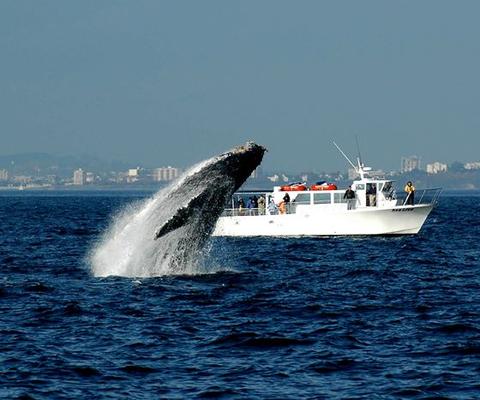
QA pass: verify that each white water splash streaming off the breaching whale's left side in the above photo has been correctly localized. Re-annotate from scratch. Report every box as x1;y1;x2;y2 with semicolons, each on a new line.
89;158;222;277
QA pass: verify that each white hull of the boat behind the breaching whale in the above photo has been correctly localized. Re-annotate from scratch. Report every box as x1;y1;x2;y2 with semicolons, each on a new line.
213;204;433;237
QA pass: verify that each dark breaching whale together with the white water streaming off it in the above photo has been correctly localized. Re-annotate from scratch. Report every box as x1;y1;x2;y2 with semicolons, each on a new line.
91;142;266;276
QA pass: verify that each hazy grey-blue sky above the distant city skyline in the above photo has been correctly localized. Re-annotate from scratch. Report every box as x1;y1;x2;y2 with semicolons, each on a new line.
0;0;480;171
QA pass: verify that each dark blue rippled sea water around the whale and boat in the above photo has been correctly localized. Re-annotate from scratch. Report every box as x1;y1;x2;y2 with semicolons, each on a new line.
0;193;480;399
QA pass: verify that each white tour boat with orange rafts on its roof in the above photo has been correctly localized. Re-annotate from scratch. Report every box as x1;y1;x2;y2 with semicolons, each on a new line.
213;149;441;236
